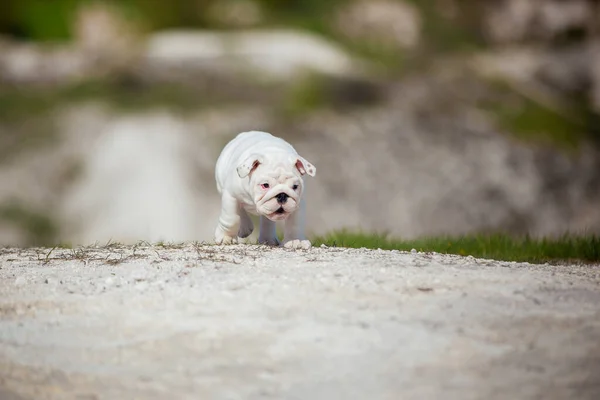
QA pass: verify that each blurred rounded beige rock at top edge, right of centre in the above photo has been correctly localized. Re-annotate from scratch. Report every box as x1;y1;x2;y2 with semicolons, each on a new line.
334;0;422;49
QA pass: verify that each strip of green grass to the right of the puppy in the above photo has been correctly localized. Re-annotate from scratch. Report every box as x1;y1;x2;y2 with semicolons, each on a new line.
313;231;600;263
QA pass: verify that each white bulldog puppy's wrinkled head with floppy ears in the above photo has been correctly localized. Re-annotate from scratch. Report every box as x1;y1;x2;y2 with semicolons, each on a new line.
237;153;317;221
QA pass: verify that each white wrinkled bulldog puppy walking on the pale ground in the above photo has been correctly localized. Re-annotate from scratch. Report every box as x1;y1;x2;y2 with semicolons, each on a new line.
215;131;317;249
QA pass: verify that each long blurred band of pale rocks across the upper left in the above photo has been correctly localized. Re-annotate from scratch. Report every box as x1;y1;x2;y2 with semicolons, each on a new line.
0;27;368;86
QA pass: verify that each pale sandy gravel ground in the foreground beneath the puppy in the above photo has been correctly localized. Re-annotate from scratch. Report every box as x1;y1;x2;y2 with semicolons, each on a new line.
0;244;600;400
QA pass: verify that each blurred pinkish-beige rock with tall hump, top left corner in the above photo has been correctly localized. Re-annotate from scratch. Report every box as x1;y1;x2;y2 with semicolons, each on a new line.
0;2;141;87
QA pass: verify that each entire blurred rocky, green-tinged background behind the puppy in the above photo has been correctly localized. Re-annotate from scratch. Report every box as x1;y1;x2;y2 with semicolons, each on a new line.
0;0;600;246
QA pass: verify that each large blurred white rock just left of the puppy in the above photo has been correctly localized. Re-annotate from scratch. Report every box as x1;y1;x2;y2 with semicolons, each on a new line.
63;113;201;243
